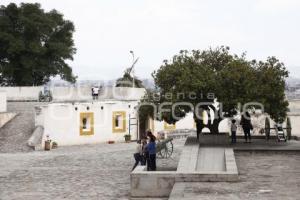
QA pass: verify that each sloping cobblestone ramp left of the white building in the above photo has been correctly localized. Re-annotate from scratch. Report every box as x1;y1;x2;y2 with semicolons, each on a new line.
0;102;45;153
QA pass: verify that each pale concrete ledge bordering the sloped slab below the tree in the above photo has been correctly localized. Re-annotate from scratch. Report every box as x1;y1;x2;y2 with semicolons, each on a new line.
130;148;239;198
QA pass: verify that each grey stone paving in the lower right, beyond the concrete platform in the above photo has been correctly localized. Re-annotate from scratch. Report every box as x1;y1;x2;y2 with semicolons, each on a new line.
171;152;300;200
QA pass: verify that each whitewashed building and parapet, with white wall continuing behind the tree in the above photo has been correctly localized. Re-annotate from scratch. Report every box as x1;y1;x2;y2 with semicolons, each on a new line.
29;88;300;145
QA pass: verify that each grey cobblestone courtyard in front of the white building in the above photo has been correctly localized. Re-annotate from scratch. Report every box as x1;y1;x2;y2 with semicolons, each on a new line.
0;139;185;200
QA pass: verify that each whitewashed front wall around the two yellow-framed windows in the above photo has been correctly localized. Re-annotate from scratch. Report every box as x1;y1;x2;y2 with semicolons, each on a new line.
36;101;137;145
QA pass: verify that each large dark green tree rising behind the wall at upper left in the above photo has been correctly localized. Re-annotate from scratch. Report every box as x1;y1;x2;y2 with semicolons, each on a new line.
0;3;76;86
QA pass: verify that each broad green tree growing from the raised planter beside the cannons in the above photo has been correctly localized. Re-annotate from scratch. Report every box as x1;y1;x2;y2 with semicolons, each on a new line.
140;46;288;137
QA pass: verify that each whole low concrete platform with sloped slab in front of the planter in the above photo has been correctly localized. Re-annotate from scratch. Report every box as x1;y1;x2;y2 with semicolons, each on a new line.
130;137;238;198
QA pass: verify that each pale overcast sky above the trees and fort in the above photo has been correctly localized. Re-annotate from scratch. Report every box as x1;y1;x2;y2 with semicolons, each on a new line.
0;0;300;80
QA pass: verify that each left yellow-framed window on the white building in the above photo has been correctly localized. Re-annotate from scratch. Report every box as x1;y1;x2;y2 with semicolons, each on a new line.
79;112;94;135
